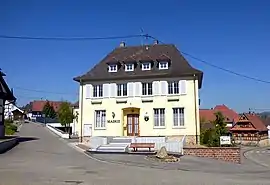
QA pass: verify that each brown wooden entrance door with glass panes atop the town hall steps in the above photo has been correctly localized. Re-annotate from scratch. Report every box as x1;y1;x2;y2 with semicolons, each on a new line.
127;114;139;136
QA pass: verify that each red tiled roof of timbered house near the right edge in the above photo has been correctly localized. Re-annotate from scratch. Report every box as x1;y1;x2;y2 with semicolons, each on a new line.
231;114;268;131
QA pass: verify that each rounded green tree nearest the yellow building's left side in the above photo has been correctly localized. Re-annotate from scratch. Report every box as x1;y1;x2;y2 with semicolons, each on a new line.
58;102;75;132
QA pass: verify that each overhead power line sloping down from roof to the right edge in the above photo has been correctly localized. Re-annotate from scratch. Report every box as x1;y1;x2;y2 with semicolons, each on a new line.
147;35;270;84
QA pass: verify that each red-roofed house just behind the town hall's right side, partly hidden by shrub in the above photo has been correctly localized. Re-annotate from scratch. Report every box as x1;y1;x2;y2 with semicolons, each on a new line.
200;104;239;129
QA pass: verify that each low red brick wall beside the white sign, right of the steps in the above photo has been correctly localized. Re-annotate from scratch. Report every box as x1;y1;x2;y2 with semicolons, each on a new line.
184;147;241;163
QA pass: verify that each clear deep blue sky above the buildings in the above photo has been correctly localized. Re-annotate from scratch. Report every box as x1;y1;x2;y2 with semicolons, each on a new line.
0;0;270;111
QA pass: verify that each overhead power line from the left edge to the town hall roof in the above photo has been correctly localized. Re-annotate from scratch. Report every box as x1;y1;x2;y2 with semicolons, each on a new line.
0;34;148;41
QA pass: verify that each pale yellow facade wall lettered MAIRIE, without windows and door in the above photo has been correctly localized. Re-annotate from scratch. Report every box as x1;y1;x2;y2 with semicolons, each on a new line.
76;77;200;142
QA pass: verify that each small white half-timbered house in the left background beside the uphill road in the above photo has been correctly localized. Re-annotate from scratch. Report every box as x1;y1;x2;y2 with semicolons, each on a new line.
5;100;24;120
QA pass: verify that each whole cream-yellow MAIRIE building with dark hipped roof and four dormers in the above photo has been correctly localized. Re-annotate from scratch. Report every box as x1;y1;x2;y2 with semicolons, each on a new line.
74;43;203;144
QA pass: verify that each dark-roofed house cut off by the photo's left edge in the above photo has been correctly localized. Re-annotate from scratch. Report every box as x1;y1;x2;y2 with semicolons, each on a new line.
0;71;16;138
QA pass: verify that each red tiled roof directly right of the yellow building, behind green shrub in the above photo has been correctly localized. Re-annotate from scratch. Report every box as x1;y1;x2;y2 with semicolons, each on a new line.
200;105;239;122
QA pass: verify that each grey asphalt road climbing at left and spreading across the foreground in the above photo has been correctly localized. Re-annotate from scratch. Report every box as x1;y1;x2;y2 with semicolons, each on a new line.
0;123;270;185
